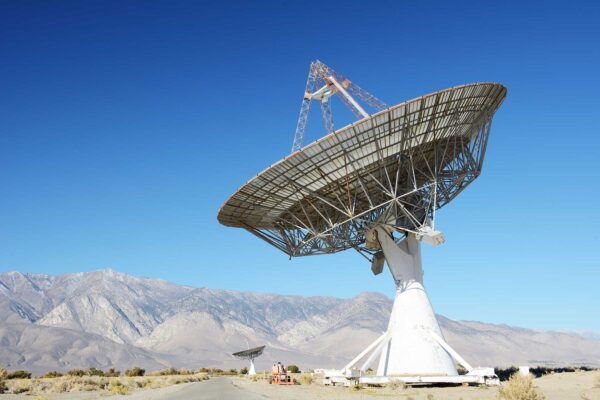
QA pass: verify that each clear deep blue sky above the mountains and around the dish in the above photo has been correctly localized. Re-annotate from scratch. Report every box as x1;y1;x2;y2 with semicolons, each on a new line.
0;1;600;330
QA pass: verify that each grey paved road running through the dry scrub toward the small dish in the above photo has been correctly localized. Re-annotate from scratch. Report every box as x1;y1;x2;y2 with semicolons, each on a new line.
128;378;267;400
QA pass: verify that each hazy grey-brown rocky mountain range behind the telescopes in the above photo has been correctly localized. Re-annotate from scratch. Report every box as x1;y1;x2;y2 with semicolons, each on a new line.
0;270;600;373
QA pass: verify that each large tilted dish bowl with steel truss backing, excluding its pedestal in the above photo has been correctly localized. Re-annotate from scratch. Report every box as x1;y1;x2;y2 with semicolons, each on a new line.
218;83;506;257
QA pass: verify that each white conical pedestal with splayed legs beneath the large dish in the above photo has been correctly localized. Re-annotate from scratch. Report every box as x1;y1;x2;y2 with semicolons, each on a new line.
343;227;473;377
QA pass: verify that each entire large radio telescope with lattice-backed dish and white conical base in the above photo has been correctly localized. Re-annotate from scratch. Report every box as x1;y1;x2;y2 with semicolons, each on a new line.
218;61;506;384
